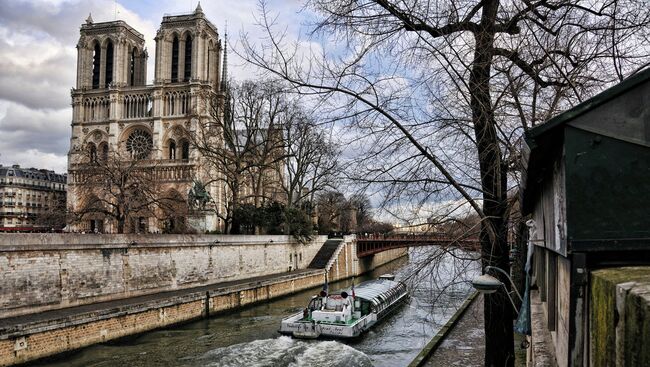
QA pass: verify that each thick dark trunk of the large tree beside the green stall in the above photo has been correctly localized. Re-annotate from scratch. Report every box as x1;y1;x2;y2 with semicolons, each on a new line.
469;0;514;367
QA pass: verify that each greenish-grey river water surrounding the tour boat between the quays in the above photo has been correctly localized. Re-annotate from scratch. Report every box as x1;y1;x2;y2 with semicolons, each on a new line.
37;247;479;367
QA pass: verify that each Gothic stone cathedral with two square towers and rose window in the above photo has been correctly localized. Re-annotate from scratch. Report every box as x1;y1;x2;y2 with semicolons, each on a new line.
68;4;227;233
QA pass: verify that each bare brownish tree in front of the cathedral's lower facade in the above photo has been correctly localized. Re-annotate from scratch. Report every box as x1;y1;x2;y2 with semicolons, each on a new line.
71;151;186;233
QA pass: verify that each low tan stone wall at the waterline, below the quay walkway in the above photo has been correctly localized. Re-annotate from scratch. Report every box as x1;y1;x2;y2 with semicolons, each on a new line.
0;270;323;366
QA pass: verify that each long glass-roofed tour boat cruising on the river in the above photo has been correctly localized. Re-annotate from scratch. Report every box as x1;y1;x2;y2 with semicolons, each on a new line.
280;277;409;339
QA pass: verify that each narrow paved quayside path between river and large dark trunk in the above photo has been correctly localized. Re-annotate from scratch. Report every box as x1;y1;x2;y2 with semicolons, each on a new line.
424;294;485;367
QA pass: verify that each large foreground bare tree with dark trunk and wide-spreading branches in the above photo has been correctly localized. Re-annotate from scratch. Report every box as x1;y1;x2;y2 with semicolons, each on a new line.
243;0;650;366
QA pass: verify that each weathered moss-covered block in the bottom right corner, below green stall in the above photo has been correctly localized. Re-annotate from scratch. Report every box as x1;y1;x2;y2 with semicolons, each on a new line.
590;266;650;367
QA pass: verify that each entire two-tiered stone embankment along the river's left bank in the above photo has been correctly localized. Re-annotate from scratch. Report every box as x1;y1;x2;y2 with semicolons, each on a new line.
0;234;407;366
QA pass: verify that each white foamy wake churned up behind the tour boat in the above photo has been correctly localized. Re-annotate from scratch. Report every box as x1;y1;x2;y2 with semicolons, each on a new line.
200;336;372;367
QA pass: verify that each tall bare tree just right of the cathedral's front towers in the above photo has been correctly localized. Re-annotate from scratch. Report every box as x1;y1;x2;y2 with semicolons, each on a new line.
189;81;287;233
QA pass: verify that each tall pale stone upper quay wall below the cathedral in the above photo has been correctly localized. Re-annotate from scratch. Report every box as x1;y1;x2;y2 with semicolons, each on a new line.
0;234;326;318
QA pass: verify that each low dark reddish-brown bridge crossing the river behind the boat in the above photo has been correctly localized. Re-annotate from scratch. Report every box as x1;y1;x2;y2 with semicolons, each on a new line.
357;234;480;258
